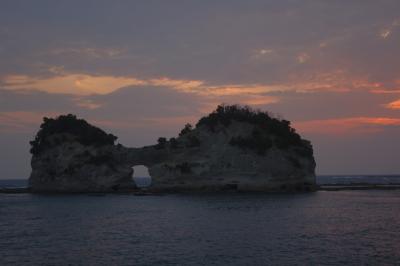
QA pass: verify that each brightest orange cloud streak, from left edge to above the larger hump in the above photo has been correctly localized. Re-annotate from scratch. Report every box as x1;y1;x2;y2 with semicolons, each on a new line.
2;74;282;98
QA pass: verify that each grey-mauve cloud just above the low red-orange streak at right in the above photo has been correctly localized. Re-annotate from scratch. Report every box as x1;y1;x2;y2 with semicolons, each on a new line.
253;89;398;121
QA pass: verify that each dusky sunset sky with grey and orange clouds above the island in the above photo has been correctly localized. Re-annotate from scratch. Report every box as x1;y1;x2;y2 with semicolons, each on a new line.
0;0;400;179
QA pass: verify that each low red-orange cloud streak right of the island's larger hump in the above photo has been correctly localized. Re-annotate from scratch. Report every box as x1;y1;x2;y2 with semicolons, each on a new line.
294;117;400;135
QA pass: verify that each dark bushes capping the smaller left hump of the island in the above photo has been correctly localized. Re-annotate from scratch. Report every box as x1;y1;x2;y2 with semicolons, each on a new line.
30;114;117;155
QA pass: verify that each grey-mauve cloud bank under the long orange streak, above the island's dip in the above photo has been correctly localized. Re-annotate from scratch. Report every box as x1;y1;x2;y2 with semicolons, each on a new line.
0;83;279;131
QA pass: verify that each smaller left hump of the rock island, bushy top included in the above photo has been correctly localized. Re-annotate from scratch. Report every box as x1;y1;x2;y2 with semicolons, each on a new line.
29;115;134;192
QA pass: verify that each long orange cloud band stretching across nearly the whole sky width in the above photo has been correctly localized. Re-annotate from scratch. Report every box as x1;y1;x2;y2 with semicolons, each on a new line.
0;67;385;102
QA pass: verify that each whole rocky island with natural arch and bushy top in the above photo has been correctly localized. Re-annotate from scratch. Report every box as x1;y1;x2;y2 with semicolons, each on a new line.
29;105;316;193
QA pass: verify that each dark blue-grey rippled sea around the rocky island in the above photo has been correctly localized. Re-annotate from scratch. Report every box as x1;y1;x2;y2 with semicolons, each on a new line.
0;176;400;265
